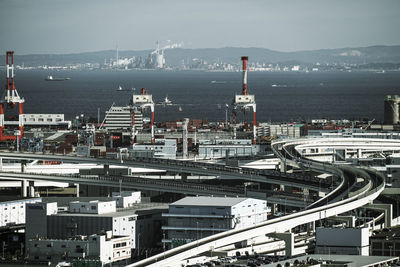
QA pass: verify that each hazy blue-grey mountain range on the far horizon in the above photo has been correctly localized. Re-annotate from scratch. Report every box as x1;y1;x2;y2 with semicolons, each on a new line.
0;45;400;66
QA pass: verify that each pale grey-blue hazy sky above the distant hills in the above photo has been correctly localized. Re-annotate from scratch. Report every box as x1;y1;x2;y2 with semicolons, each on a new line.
0;0;400;54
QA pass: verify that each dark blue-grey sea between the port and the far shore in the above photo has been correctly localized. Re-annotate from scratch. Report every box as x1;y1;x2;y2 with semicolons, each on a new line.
0;69;400;122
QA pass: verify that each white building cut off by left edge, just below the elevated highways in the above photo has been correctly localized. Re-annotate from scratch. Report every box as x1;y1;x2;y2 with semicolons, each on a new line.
0;198;42;227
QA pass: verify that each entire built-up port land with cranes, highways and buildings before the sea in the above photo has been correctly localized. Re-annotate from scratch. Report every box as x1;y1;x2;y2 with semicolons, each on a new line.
0;51;400;266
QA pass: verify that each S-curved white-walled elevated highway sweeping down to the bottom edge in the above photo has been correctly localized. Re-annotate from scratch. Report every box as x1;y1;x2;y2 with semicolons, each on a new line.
128;140;385;267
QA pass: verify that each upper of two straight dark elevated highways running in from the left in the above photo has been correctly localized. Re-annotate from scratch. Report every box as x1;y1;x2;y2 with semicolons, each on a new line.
0;152;331;192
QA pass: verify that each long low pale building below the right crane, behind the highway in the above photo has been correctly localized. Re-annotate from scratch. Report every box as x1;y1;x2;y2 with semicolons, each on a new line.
198;139;259;159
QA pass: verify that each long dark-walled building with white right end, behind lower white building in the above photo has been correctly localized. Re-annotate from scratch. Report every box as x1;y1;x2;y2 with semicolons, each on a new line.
26;201;137;248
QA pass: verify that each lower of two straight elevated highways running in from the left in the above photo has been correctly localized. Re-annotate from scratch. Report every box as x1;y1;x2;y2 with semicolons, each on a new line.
0;171;310;208
